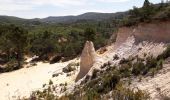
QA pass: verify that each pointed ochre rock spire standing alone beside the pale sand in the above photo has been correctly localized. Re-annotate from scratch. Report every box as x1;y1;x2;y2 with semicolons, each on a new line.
76;41;97;81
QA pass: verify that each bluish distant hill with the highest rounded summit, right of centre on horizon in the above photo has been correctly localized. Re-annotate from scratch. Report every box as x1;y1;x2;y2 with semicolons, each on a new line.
40;12;126;23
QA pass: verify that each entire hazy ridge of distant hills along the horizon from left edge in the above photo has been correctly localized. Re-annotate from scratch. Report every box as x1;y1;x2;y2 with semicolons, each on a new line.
0;12;126;25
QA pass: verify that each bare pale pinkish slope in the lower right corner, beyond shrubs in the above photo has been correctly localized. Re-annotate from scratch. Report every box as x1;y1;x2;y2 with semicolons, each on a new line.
131;64;170;100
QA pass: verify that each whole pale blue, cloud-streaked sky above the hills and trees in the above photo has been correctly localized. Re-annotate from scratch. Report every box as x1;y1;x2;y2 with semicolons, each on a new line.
0;0;161;19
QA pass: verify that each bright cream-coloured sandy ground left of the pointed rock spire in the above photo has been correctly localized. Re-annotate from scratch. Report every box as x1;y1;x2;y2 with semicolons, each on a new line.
0;59;78;100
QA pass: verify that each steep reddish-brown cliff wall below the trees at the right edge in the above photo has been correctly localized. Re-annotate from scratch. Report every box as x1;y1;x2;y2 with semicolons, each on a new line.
115;21;170;47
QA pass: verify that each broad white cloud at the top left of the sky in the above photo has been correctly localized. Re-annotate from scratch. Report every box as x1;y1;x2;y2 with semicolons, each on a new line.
0;0;87;11
